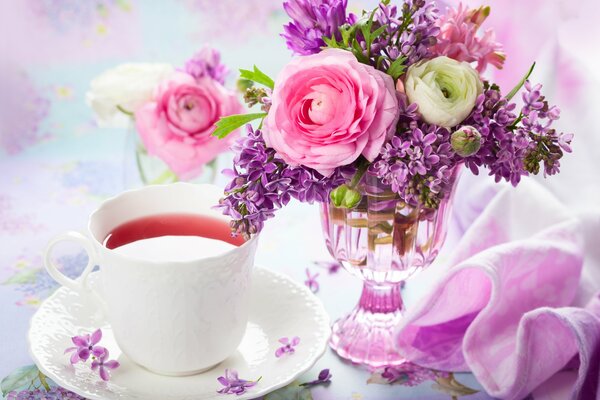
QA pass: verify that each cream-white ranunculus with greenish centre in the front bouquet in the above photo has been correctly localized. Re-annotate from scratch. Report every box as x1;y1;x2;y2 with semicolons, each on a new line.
404;56;483;128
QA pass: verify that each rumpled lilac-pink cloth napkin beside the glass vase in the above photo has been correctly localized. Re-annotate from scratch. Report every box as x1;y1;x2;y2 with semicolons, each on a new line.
397;180;600;399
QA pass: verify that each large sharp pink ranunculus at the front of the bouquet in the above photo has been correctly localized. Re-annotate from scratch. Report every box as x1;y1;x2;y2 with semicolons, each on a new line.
264;49;398;176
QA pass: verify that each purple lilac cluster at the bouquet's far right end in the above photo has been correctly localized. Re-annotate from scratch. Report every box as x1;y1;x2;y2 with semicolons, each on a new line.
463;82;573;186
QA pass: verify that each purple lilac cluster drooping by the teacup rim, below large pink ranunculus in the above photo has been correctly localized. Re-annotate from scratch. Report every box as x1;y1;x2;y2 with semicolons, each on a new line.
217;125;354;237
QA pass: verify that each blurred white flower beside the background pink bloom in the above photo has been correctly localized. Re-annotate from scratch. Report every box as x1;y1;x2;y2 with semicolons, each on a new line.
86;63;174;127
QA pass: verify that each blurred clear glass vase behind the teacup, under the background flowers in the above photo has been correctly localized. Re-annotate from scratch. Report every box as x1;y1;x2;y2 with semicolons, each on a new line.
124;127;218;189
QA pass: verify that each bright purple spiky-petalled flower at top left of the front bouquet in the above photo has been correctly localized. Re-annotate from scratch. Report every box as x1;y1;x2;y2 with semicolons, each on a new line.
282;0;348;55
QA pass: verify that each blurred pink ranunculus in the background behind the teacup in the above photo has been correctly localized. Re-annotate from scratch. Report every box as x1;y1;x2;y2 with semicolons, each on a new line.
135;72;242;179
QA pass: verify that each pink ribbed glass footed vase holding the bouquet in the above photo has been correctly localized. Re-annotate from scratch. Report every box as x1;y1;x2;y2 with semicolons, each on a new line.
321;166;461;368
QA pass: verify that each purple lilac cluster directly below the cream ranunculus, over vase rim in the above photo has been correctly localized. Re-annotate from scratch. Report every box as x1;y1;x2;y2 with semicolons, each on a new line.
368;95;458;208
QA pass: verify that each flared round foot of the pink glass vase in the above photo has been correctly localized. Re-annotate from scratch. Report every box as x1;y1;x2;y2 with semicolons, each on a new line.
329;307;407;368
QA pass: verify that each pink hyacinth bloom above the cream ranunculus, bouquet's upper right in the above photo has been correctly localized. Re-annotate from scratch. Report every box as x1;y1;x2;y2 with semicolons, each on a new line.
433;3;506;73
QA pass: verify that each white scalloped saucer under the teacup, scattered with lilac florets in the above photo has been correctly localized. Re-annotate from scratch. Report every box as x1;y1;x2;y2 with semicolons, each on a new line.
28;267;330;400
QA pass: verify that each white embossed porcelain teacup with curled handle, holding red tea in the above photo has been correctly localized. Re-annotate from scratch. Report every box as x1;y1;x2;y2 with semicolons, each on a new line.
45;183;258;376
